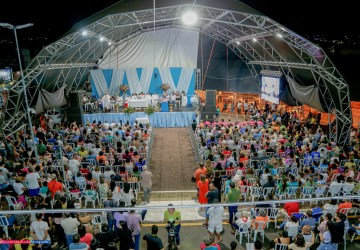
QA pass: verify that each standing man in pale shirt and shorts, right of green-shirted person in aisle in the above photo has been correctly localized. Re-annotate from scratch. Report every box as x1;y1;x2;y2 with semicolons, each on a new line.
207;199;224;242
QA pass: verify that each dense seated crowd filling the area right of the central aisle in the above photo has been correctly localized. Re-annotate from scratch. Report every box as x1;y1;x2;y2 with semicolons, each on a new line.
193;105;360;249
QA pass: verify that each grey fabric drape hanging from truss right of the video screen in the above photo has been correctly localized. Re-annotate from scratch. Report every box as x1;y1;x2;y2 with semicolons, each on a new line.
286;76;324;112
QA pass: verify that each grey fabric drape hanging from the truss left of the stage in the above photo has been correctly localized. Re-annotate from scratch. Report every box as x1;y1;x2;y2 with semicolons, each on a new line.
35;85;67;114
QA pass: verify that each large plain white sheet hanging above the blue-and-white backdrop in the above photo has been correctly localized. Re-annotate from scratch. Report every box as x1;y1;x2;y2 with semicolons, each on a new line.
99;28;199;69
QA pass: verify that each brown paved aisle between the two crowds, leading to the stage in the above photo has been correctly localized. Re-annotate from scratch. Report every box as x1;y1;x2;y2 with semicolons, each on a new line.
150;128;197;191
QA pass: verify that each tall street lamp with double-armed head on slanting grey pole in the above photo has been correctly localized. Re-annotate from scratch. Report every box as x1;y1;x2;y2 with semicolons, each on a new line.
0;23;40;164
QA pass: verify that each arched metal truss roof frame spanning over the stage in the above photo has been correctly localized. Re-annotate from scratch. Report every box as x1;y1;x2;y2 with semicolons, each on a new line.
2;4;352;144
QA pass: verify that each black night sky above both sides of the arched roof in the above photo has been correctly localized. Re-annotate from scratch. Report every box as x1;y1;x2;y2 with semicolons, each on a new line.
0;0;359;40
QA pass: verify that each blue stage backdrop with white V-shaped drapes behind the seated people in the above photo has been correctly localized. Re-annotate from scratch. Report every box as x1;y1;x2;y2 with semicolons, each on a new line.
91;67;195;104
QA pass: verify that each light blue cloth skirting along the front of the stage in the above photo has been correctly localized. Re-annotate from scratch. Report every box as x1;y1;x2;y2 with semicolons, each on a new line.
82;111;195;128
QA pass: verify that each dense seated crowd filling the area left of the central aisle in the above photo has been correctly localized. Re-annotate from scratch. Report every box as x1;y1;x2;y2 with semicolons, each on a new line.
0;121;158;249
